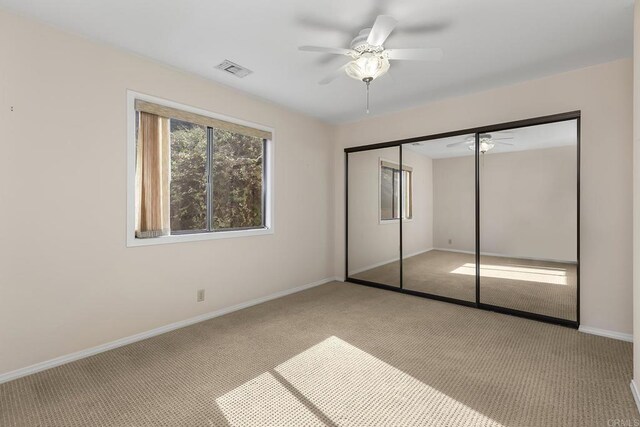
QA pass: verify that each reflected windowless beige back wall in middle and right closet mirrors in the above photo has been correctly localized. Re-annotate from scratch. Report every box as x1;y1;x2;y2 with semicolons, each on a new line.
433;146;578;262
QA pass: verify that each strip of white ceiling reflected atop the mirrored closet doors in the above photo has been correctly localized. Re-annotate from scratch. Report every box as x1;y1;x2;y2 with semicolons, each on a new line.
403;120;578;159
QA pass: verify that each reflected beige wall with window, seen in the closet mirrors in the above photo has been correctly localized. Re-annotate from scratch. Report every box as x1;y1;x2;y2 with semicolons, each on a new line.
349;148;433;274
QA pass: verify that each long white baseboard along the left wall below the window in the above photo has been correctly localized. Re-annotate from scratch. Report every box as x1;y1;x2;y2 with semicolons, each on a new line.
0;277;338;384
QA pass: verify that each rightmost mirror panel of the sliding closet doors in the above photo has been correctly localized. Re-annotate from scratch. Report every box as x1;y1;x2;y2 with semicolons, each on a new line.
479;120;578;321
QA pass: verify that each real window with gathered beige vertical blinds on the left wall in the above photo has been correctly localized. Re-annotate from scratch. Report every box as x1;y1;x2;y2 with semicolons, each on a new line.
128;93;272;246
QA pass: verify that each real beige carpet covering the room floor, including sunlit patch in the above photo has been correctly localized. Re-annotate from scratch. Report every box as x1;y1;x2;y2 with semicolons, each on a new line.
0;282;640;427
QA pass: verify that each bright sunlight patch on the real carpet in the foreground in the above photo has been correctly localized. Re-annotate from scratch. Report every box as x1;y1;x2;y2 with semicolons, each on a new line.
216;336;501;427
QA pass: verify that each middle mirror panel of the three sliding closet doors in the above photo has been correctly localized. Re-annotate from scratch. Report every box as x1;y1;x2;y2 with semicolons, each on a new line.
402;134;476;302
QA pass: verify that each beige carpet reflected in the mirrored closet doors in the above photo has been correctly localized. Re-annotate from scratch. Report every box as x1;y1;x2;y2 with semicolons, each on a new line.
353;250;578;320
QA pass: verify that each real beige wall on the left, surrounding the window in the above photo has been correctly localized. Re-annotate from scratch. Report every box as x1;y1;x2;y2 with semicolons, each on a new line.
0;12;334;374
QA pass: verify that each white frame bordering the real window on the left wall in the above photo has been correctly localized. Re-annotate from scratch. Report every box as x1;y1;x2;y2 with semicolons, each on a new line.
127;90;275;247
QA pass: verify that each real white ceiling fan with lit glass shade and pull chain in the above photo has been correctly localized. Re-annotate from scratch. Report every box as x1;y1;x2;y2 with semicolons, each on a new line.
298;15;442;113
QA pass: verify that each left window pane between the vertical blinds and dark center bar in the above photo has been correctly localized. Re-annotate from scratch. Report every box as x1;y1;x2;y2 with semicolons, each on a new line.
170;119;207;233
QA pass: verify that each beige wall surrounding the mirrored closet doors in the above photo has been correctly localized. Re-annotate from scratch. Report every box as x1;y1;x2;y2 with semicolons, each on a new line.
334;60;633;334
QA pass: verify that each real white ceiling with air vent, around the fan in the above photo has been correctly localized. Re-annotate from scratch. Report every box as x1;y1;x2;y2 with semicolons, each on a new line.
0;0;633;122
